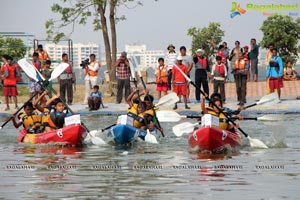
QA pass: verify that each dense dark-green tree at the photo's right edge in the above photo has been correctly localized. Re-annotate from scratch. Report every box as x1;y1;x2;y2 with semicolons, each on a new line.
260;15;300;62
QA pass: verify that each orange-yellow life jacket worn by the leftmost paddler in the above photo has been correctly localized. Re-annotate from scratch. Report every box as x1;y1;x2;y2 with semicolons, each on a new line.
18;110;41;131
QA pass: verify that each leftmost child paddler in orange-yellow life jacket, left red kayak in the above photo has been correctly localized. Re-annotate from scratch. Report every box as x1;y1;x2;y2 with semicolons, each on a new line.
11;102;41;133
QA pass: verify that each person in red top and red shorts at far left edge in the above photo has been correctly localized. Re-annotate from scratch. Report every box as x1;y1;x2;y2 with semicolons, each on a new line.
1;55;20;111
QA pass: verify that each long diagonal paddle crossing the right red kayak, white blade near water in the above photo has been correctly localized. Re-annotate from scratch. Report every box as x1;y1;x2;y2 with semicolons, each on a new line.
175;65;268;148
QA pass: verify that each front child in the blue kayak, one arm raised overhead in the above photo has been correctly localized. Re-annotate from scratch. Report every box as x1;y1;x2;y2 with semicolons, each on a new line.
127;89;154;131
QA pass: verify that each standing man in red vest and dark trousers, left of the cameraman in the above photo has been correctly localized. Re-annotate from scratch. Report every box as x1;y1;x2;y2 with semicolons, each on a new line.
58;53;73;105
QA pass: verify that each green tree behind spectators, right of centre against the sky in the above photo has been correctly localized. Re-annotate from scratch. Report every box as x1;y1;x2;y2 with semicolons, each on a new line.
187;22;225;62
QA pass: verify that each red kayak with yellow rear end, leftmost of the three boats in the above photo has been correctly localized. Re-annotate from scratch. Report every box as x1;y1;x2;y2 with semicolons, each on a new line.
18;124;87;146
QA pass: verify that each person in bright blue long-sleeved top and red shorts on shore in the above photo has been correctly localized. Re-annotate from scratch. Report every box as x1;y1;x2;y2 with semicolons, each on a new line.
266;48;283;98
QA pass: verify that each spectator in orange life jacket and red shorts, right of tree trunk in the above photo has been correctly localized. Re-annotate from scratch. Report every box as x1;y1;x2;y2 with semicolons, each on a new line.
155;58;168;99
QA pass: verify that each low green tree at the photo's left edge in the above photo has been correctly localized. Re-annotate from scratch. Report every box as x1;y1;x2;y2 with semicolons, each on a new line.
0;36;26;61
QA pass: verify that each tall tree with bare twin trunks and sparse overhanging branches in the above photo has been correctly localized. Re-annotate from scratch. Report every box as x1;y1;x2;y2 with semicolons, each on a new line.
45;0;146;88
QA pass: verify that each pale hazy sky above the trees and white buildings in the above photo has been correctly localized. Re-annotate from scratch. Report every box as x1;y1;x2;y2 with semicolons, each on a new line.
0;0;300;51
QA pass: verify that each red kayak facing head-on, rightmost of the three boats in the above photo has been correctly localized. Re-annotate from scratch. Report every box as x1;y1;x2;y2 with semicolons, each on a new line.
189;126;242;153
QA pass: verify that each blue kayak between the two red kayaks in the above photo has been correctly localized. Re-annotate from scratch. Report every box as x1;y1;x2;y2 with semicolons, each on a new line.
107;124;155;145
